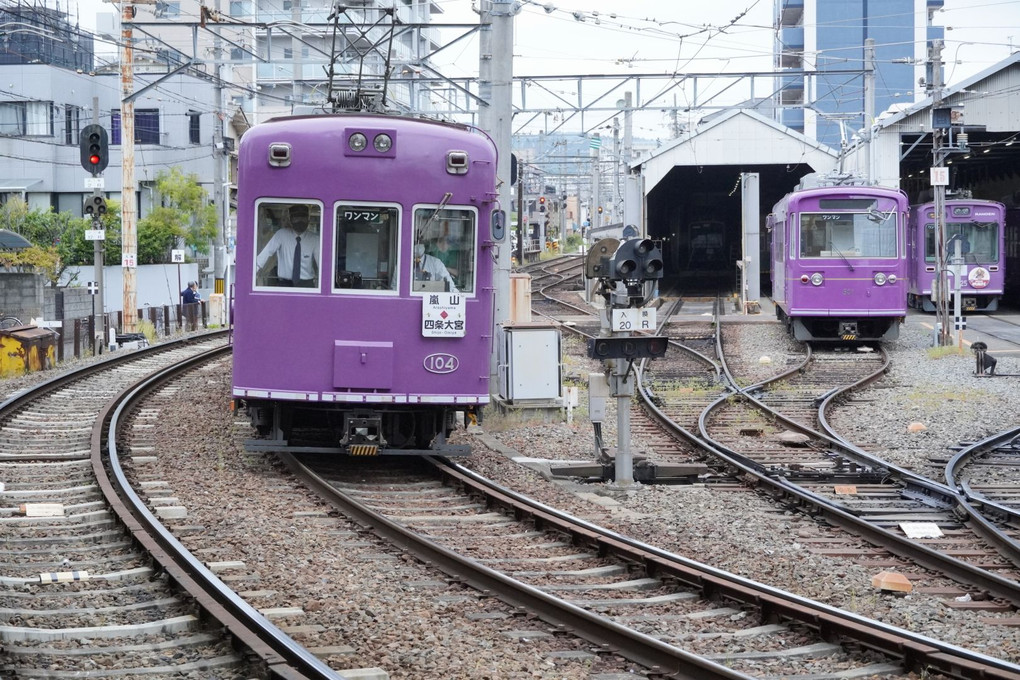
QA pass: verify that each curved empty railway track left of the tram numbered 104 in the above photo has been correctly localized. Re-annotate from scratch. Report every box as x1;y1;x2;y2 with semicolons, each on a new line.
0;331;339;680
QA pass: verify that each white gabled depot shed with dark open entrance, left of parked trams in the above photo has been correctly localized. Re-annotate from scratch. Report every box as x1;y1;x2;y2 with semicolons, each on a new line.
632;108;837;291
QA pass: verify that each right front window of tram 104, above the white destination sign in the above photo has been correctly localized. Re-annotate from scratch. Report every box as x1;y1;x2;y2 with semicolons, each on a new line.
411;208;477;294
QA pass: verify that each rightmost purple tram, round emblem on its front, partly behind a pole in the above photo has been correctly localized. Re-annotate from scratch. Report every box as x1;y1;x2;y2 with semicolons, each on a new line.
907;199;1006;312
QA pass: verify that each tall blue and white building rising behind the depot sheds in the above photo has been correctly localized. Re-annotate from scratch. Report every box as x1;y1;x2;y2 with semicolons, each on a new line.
774;0;945;149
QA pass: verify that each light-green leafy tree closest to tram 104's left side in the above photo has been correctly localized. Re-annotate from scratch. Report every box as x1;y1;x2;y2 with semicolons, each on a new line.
138;166;216;264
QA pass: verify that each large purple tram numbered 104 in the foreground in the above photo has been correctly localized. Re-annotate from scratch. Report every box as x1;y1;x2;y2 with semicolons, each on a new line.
233;113;505;456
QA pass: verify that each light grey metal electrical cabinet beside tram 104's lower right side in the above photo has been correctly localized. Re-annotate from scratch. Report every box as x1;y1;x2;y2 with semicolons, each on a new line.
498;323;563;402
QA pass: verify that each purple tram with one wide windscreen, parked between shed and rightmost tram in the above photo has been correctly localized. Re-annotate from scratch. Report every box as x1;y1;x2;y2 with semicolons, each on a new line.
766;175;909;342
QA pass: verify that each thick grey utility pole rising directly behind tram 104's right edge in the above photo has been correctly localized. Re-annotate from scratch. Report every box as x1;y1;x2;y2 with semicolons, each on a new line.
478;0;514;390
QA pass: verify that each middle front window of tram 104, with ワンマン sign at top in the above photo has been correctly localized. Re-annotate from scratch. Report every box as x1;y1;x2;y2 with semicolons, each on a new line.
334;205;400;291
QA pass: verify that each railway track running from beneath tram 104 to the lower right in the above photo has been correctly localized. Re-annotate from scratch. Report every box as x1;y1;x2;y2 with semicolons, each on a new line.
288;458;1020;678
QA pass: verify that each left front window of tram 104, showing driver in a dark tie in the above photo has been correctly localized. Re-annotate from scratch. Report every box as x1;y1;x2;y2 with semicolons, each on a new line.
255;201;322;289
